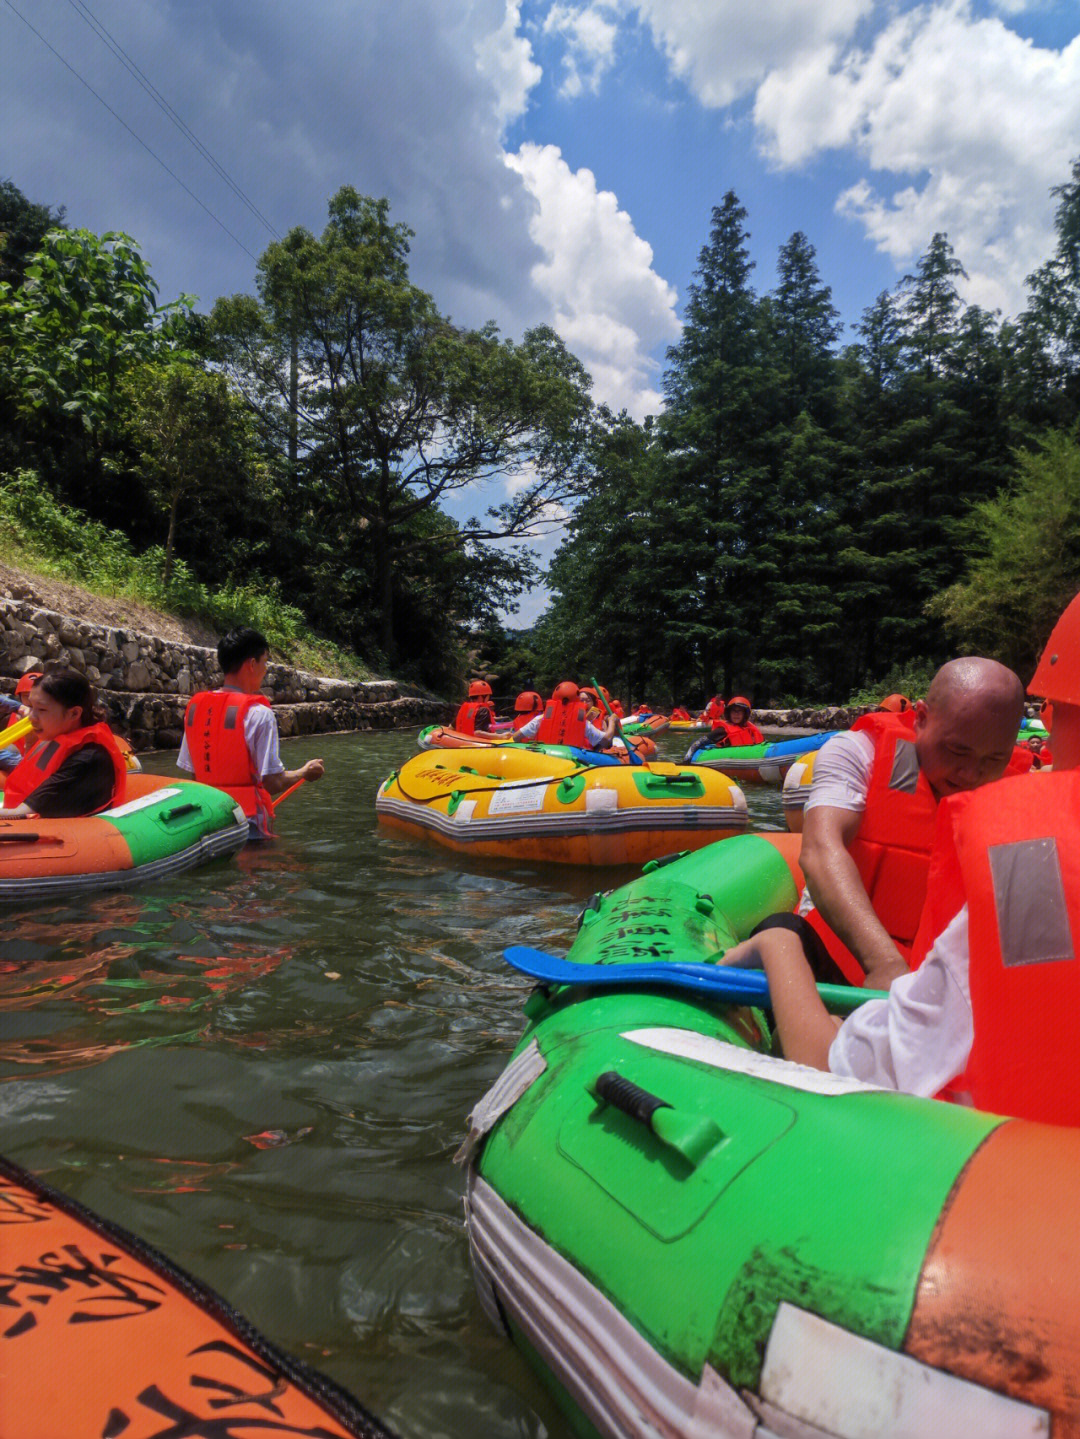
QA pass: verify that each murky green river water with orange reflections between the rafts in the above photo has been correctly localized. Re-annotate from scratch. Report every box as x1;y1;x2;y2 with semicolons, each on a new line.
0;732;782;1439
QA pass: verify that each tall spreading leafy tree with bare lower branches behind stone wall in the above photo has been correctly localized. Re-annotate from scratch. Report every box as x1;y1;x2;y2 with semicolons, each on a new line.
213;186;590;658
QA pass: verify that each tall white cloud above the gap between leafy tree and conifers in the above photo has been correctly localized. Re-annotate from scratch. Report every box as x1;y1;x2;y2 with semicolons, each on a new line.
506;144;679;419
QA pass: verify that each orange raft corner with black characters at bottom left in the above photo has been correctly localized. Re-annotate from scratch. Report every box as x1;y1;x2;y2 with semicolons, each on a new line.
0;1158;393;1439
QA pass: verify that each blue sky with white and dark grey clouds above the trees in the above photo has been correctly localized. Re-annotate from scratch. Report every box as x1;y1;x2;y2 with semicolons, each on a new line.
0;0;1080;623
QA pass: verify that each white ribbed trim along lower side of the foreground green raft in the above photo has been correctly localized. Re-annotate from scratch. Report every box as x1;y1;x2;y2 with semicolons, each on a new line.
465;1171;759;1439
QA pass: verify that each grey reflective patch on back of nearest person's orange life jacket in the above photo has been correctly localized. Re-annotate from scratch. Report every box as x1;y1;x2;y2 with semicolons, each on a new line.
988;837;1076;968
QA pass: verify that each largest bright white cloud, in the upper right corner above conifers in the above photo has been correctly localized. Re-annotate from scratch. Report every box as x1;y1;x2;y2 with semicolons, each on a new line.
754;0;1080;312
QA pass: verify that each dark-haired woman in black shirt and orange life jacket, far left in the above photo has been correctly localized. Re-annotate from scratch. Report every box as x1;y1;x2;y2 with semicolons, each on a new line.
0;668;128;819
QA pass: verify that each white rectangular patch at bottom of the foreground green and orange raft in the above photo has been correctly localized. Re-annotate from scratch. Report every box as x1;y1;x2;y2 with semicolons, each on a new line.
761;1302;1050;1439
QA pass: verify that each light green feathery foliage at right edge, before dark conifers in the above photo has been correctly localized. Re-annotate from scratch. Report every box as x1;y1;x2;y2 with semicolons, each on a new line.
932;432;1080;679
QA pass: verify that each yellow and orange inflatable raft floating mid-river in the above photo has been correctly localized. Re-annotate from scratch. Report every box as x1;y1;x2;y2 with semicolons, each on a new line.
375;745;748;865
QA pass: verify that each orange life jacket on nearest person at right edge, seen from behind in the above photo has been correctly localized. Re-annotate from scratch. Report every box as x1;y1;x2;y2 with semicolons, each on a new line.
942;770;1080;1125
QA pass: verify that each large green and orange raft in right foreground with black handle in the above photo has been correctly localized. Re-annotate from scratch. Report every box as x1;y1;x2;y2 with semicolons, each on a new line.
460;835;1080;1439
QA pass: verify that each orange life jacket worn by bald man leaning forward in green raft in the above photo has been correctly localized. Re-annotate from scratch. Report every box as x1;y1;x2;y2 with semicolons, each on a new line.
807;709;938;984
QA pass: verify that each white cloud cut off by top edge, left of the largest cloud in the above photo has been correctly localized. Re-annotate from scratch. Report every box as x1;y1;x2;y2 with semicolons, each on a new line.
621;0;876;106
